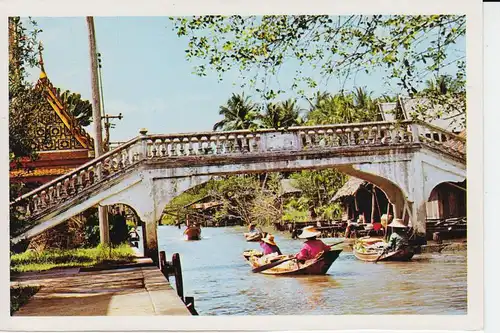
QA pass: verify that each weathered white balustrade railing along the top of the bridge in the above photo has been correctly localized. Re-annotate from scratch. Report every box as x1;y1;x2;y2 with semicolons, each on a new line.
11;121;465;223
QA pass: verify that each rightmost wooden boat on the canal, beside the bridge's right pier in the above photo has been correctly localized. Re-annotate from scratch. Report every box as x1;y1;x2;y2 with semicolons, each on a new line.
352;238;415;262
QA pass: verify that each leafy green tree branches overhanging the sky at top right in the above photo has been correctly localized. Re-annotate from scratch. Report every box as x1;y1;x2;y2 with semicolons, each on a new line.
171;15;466;99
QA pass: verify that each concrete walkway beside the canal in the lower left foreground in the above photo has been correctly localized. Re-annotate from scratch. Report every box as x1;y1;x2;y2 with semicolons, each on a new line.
11;258;190;316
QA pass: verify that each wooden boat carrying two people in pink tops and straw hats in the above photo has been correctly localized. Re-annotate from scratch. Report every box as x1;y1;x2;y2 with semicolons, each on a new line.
243;250;342;275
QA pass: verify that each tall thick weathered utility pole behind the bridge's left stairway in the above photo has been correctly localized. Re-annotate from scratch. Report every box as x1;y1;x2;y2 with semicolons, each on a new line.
87;16;109;245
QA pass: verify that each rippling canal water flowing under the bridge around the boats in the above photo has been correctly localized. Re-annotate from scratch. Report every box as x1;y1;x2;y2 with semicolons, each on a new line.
158;226;467;315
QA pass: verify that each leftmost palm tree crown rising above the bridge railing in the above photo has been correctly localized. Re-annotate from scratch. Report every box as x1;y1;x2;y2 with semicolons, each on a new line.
213;93;258;131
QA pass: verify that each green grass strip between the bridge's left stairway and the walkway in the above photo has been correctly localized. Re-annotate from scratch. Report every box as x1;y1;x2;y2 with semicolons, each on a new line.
10;244;134;273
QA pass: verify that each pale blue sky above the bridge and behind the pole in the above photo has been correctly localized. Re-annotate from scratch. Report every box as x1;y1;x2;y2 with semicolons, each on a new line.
27;17;464;141
